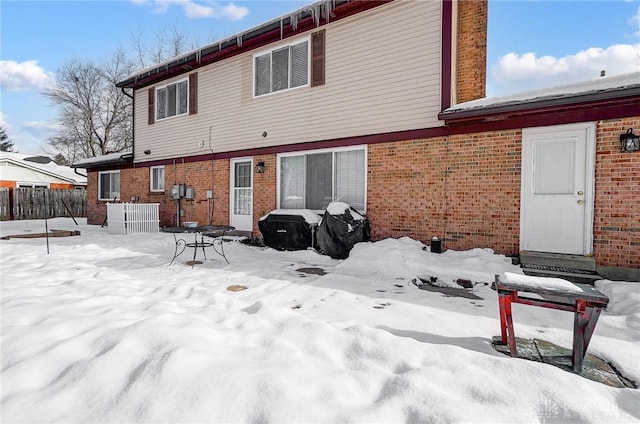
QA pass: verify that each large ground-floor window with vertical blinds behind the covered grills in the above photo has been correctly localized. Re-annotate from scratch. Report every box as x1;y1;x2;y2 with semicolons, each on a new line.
279;148;366;212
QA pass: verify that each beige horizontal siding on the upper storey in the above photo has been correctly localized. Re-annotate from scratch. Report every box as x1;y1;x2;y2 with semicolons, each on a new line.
134;1;443;162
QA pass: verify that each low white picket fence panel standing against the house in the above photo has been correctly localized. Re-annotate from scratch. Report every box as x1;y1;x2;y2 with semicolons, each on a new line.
107;203;160;234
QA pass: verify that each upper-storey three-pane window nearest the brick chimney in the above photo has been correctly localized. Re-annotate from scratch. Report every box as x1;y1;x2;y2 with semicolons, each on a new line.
253;40;309;97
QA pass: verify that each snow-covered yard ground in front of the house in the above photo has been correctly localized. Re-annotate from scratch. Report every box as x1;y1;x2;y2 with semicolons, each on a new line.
0;218;640;423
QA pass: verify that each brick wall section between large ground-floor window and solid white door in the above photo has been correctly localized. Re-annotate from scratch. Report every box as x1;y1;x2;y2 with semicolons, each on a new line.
367;131;522;254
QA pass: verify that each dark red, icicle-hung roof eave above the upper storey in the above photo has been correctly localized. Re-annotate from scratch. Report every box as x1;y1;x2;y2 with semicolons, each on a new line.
116;0;394;89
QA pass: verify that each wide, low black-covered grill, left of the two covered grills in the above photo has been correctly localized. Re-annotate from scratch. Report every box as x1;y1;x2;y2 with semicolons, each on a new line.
258;214;313;250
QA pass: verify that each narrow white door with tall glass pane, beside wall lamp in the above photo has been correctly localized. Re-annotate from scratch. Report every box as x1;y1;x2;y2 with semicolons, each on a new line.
230;159;253;231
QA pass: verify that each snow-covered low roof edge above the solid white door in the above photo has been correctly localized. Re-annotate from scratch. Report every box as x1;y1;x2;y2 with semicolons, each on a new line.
440;72;640;119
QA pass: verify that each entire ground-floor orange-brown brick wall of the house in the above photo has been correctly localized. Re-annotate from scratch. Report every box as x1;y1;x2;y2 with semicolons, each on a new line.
87;117;640;268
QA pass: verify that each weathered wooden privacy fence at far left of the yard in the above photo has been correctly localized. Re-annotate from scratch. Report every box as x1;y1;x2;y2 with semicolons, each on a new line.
0;187;87;221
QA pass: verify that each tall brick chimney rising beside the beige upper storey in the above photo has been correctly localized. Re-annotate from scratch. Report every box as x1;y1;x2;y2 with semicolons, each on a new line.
456;0;489;103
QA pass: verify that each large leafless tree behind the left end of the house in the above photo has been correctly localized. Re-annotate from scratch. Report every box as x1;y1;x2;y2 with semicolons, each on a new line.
44;27;192;163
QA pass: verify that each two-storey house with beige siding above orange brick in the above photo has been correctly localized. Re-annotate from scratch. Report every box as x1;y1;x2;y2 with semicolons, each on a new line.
74;0;640;282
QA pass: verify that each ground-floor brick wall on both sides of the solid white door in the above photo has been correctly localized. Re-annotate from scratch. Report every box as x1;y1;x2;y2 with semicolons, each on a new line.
367;117;640;269
